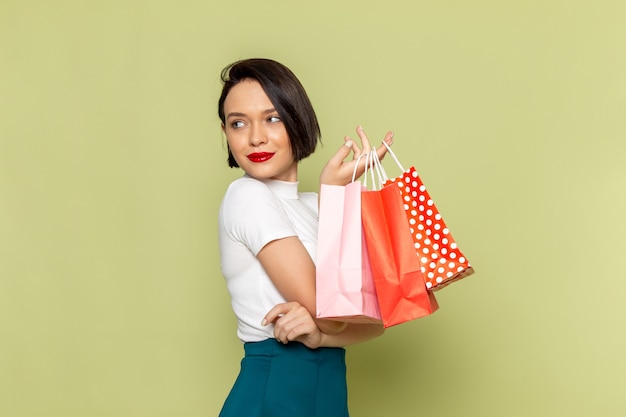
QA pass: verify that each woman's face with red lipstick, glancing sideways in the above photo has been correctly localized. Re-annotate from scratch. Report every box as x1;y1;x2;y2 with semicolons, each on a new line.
222;80;298;182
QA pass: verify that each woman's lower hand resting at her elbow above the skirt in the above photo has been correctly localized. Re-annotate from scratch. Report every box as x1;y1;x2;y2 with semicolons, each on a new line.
262;301;322;349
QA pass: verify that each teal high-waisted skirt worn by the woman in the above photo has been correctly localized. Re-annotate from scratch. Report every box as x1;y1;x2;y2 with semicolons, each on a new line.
220;339;348;417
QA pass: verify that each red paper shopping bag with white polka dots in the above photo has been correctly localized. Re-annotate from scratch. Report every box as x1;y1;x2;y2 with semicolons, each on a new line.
383;142;474;291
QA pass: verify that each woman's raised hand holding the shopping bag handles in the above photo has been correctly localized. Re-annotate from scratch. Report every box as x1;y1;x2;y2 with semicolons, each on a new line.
320;126;393;185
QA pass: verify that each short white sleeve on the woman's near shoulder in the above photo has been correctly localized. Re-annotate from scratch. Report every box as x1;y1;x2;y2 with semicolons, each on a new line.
219;177;297;256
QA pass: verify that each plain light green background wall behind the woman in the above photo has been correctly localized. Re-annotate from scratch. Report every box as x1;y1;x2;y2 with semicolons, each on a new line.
0;0;626;417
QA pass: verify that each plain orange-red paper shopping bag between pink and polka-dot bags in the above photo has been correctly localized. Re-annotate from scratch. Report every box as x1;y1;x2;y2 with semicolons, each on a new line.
361;150;439;327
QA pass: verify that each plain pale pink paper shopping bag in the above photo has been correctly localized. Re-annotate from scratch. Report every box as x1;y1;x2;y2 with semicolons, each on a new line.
316;181;381;323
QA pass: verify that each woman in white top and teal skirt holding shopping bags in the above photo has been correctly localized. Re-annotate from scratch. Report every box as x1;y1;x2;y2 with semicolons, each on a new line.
218;59;393;417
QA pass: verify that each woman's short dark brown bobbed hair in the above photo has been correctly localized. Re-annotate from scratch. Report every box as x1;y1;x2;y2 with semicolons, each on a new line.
217;58;321;168
